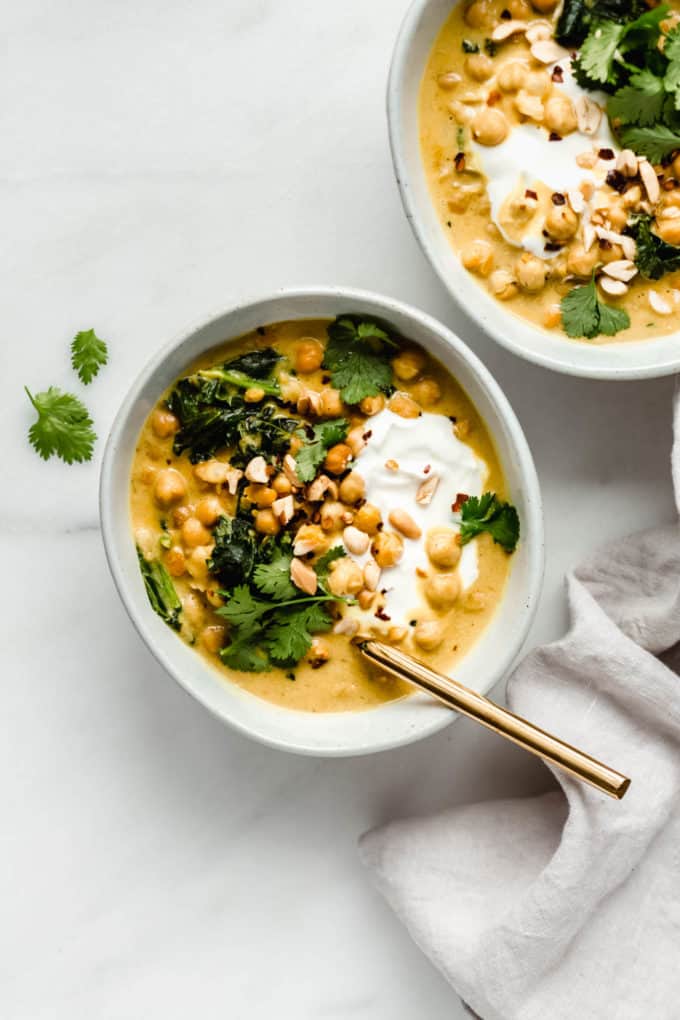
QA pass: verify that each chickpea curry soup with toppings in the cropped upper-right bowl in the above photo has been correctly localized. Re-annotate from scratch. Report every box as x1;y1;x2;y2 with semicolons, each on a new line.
420;0;680;343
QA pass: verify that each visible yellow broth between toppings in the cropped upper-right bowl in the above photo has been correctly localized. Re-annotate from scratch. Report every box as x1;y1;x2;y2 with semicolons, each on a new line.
419;0;680;344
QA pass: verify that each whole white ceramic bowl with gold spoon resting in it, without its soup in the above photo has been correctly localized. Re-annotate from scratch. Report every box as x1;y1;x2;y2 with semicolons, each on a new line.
100;289;543;755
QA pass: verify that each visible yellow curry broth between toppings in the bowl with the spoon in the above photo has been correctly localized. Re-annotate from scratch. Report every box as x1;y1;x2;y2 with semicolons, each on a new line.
130;321;510;712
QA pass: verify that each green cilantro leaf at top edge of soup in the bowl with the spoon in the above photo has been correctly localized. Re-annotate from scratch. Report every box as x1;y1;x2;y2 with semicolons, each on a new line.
323;315;398;404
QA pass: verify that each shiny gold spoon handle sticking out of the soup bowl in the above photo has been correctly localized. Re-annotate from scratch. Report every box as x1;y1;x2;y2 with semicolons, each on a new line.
359;641;630;801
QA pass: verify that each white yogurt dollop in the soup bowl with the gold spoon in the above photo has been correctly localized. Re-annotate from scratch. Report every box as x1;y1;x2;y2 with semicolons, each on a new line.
348;409;488;630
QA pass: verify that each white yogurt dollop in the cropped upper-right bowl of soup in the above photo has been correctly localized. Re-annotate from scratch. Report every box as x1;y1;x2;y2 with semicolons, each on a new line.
472;58;619;259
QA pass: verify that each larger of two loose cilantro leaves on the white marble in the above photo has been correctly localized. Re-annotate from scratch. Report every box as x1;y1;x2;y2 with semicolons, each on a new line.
24;386;97;464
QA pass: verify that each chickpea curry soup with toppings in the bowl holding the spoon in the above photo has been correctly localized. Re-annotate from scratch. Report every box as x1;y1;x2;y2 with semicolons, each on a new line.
130;315;519;712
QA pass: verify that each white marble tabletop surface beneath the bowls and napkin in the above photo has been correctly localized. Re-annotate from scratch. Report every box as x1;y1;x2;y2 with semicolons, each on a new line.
0;0;673;1020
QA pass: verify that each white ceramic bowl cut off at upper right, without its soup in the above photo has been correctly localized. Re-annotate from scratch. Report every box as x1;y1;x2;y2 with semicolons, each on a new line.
387;0;680;379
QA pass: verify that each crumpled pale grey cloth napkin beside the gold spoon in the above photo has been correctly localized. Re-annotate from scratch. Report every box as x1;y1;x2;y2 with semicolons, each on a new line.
361;385;680;1020
